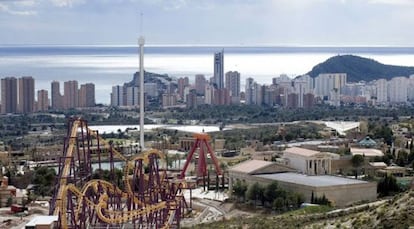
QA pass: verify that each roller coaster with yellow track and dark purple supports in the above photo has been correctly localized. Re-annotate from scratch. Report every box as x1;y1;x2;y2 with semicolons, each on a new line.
49;118;187;229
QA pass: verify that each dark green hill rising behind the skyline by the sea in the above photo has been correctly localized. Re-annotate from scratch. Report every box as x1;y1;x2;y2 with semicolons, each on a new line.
307;55;414;82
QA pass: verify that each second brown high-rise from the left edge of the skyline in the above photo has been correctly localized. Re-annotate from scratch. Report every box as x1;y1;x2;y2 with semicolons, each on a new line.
18;76;35;114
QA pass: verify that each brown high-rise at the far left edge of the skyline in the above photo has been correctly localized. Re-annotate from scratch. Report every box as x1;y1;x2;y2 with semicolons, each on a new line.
1;77;17;114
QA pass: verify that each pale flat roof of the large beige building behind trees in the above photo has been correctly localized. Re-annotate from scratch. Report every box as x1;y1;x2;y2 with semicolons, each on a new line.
256;172;368;187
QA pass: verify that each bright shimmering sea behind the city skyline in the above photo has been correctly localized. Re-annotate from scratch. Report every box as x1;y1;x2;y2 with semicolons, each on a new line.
0;45;414;104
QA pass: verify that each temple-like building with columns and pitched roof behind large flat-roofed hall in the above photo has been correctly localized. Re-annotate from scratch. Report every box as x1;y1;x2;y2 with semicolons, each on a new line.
283;147;332;175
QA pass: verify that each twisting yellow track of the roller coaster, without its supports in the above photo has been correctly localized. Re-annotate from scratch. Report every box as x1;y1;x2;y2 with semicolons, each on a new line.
53;119;185;228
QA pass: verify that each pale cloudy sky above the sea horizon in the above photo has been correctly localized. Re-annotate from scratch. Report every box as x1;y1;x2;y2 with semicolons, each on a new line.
0;0;414;46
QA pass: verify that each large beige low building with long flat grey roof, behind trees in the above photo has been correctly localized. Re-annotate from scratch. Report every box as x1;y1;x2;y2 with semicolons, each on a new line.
229;160;377;207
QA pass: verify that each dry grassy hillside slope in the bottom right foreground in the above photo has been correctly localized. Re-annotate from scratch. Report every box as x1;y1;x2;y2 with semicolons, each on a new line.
193;191;414;229
